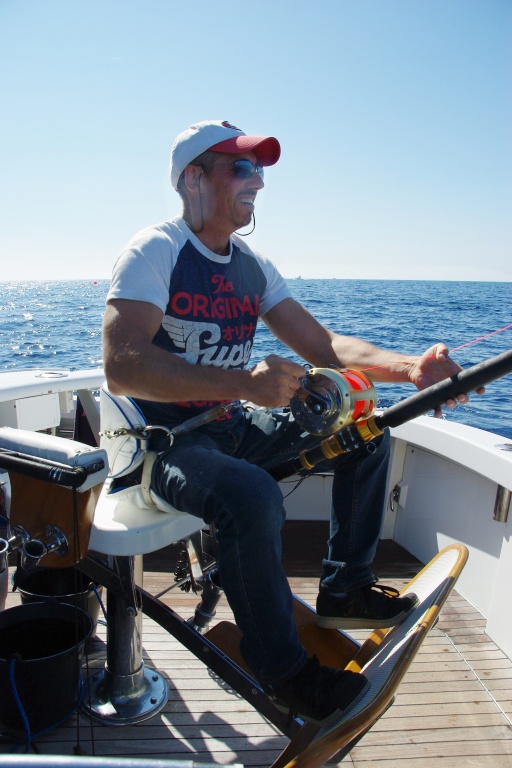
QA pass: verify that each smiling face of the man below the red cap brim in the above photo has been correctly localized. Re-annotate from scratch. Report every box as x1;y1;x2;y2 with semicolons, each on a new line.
201;152;264;234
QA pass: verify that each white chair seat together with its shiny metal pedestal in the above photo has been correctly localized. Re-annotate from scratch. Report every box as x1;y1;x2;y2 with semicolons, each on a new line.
83;483;212;725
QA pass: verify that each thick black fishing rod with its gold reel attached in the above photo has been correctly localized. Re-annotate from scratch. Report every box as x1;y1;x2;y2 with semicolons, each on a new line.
268;349;512;480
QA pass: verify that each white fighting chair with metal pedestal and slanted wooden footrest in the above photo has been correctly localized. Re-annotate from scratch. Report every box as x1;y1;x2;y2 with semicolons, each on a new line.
0;396;467;768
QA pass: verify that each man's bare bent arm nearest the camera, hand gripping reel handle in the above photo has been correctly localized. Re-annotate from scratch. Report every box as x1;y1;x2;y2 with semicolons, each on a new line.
103;299;304;407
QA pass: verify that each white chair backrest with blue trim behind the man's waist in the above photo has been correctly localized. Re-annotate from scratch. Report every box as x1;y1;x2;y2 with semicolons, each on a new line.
100;383;147;478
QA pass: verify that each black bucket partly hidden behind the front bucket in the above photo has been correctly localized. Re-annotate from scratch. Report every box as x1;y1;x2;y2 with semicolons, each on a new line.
12;568;101;638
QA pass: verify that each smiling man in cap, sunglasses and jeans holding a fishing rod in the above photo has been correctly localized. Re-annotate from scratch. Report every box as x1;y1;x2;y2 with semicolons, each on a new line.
104;121;472;725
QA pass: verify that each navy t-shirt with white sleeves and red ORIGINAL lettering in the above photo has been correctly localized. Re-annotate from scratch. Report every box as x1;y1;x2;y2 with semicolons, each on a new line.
107;217;291;423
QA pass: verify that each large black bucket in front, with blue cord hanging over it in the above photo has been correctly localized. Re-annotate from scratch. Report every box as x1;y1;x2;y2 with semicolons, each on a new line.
0;602;92;737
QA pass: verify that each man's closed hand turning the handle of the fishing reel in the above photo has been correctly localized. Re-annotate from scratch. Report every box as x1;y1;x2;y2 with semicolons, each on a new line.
247;355;304;408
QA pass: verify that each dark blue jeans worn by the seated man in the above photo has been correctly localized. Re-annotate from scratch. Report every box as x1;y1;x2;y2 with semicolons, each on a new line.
152;410;389;683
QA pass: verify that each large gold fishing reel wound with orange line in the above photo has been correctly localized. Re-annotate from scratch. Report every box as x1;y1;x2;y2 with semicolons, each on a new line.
290;368;377;437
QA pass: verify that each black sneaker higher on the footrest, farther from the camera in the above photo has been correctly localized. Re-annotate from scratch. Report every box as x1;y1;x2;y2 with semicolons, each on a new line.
316;584;419;629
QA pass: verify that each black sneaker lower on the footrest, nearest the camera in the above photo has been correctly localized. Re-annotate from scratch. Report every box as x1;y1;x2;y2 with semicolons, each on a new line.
267;656;369;726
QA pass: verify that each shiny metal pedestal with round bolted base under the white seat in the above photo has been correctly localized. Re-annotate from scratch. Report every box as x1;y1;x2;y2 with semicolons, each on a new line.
83;555;169;725
